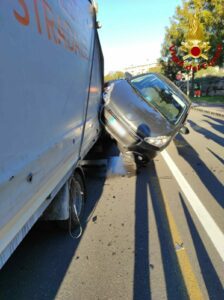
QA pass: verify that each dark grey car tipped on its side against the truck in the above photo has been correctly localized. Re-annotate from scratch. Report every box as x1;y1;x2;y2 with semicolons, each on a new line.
101;73;191;165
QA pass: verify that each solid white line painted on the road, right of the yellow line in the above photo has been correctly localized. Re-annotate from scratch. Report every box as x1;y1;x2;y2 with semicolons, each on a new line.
161;150;224;262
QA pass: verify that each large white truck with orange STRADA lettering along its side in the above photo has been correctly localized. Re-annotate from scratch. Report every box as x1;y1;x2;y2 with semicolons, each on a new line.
0;0;103;268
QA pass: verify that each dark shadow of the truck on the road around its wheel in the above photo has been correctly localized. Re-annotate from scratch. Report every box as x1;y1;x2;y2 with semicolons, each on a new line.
0;170;104;300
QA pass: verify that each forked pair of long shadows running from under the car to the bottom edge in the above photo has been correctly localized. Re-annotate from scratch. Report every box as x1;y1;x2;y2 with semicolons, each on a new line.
133;162;188;300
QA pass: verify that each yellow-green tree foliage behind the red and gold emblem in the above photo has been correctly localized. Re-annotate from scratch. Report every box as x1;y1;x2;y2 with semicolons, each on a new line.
160;0;224;80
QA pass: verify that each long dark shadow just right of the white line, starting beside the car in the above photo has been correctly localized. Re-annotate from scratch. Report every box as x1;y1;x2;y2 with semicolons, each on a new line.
174;134;224;208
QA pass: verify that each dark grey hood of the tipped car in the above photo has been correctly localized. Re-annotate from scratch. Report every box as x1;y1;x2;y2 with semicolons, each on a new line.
106;80;175;137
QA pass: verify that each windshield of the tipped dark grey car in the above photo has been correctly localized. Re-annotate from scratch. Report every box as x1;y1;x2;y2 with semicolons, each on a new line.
129;74;186;124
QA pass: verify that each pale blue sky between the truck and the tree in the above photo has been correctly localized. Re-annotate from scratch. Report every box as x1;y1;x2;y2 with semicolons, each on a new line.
97;0;182;74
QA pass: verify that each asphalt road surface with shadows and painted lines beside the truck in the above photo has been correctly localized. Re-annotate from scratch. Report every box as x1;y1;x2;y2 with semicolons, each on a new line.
0;111;224;300
